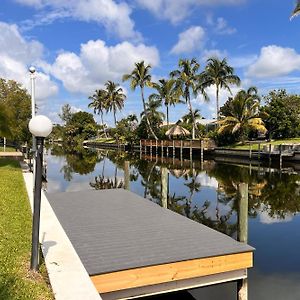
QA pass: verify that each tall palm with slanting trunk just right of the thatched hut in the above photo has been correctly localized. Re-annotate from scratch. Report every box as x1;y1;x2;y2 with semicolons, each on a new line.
170;58;207;139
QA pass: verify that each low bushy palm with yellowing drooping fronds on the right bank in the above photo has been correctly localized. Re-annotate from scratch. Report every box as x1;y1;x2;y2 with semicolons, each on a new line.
218;87;267;138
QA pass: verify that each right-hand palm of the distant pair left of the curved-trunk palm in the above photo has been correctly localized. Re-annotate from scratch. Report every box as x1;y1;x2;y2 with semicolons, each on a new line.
105;80;126;126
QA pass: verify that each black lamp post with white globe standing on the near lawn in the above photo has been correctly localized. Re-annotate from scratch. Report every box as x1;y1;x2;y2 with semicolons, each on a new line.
29;115;52;271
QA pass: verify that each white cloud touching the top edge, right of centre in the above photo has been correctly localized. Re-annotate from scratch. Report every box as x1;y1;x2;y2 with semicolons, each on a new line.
136;0;245;24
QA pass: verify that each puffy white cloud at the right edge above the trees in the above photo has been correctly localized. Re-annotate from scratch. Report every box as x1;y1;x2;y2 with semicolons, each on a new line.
246;45;300;78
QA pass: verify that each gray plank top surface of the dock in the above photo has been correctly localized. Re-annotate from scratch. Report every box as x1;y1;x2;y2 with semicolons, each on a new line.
47;189;254;275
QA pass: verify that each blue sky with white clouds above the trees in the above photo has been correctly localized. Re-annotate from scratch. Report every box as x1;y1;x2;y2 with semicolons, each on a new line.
0;0;300;124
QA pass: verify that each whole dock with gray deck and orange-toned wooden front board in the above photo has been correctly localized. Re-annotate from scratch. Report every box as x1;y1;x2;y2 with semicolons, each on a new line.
47;189;254;299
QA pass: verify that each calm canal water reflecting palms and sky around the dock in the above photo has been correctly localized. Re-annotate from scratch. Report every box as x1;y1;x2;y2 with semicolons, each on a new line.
45;146;300;300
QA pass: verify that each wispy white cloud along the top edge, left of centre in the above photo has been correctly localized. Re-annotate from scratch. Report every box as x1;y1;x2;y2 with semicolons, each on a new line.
15;0;140;39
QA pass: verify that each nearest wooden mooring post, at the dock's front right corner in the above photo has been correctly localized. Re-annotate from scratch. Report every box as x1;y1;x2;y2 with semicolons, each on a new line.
237;183;248;300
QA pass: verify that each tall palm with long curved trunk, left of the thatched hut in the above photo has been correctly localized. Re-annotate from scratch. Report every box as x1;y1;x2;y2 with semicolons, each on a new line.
123;61;158;140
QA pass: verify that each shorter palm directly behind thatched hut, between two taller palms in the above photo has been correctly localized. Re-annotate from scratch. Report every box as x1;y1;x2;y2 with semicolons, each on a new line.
149;79;181;129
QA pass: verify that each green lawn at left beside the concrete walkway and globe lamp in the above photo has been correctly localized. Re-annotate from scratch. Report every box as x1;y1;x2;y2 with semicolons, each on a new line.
0;158;54;300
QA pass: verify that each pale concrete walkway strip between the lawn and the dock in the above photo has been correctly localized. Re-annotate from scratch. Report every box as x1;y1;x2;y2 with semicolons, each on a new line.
21;163;101;300
